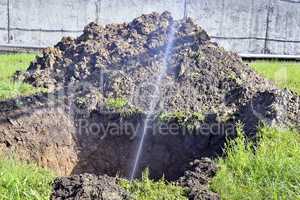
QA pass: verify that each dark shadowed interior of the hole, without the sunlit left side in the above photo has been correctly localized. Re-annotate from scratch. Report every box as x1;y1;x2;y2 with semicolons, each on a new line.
73;112;234;180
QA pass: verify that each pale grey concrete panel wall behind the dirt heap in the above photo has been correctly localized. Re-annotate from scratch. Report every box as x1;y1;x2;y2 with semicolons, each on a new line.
0;0;300;55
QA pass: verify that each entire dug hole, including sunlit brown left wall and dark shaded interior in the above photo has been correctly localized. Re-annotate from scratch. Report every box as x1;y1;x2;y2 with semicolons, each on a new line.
0;94;235;181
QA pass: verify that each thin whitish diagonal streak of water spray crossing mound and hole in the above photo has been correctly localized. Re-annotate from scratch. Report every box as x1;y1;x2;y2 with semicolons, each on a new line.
130;23;177;180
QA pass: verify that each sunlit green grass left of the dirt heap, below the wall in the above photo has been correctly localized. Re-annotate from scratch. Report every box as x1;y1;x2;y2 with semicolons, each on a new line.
0;54;43;100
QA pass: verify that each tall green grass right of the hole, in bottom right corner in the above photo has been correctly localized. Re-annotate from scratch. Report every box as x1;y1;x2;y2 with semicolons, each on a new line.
211;128;300;200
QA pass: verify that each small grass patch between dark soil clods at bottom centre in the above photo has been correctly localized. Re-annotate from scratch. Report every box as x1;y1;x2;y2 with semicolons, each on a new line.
119;170;187;200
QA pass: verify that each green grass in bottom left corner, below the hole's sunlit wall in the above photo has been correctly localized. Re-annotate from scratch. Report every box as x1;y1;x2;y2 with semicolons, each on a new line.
0;158;54;200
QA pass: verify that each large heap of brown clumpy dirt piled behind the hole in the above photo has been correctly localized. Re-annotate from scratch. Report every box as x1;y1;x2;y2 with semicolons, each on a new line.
19;12;299;133
